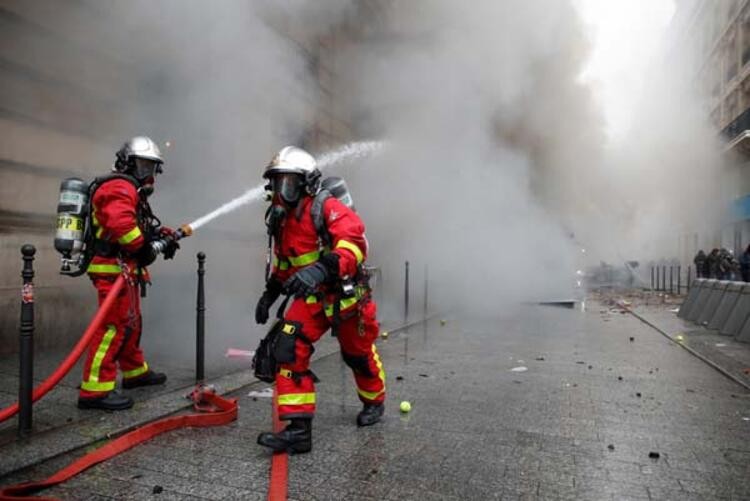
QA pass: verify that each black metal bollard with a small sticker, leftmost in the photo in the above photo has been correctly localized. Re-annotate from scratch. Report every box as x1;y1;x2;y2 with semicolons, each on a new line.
18;244;36;436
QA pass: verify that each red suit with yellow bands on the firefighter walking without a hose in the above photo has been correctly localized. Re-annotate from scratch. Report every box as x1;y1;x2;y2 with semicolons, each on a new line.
272;197;385;420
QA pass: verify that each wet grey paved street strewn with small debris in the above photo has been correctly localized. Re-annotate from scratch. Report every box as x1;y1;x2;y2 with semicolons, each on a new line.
1;304;750;500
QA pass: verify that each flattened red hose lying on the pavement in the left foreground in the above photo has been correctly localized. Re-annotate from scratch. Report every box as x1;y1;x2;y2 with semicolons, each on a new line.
0;387;237;501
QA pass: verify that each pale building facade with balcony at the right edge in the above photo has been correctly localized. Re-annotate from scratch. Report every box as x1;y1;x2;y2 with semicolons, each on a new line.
672;0;750;262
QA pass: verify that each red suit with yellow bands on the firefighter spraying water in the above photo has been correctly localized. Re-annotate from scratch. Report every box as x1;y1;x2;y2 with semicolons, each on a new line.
80;179;148;398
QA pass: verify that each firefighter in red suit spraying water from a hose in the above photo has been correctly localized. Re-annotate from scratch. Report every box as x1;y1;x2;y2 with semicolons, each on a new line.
78;137;179;410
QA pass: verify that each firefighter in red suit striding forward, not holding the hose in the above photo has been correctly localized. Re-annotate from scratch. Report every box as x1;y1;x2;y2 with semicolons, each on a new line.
255;146;385;453
